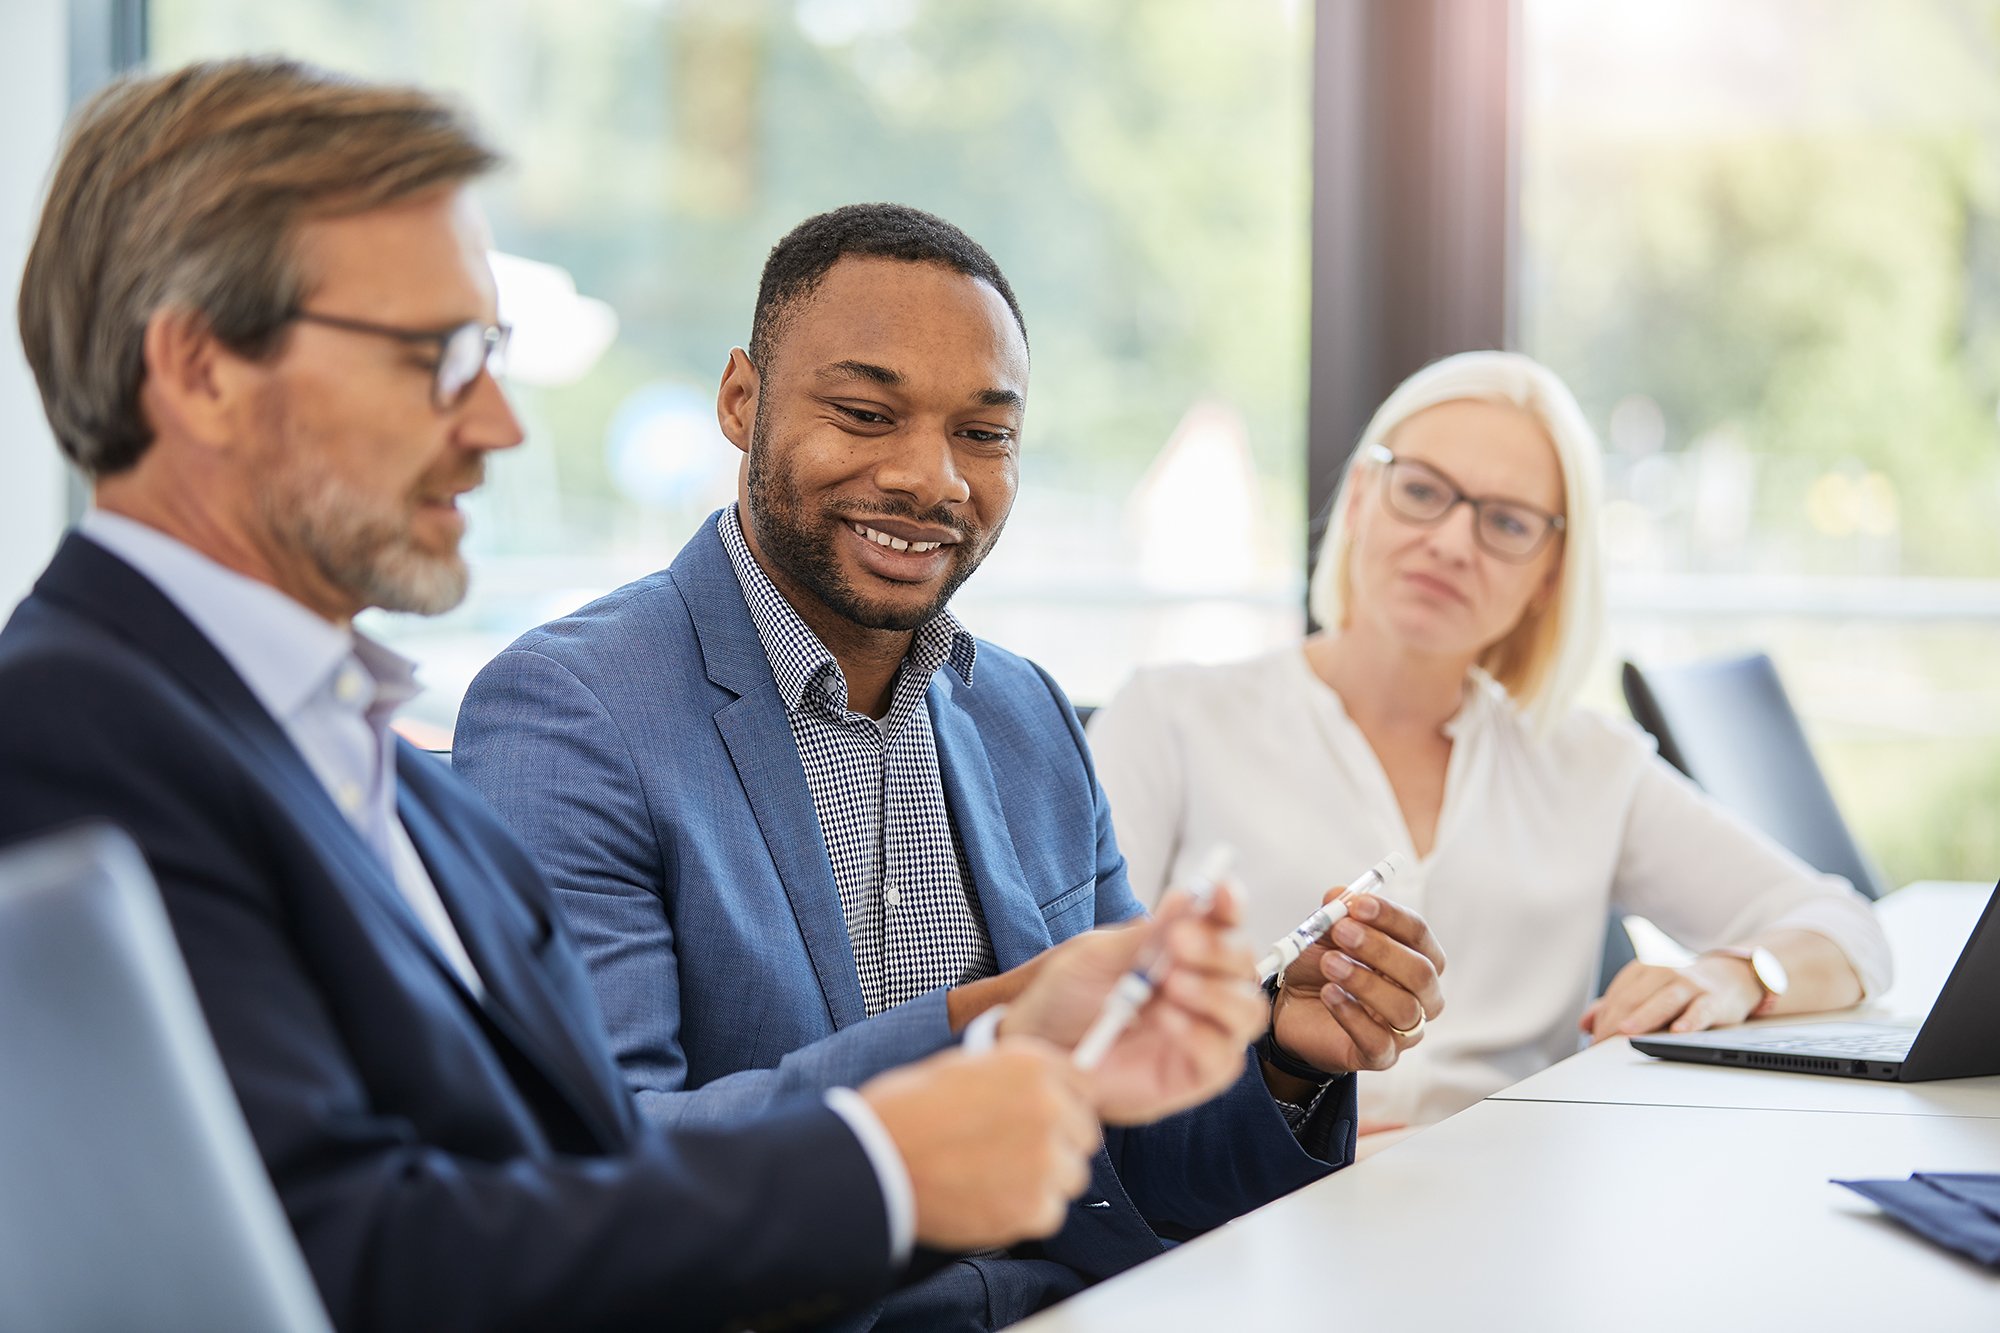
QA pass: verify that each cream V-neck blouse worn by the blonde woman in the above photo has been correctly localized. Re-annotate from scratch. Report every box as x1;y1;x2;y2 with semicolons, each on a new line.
1090;646;1890;1123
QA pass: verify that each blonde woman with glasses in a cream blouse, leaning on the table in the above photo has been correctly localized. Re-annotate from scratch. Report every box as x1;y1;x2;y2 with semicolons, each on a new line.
1090;352;1888;1131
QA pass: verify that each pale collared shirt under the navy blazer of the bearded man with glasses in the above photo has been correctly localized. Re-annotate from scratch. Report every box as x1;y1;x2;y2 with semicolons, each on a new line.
78;508;486;997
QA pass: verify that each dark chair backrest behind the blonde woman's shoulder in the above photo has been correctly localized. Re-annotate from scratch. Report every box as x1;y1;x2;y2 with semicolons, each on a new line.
1624;652;1884;899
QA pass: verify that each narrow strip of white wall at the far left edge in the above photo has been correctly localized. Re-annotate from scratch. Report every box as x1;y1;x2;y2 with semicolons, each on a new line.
0;0;70;620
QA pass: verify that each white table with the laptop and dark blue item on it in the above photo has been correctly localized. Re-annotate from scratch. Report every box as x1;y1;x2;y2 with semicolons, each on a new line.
1018;885;2000;1333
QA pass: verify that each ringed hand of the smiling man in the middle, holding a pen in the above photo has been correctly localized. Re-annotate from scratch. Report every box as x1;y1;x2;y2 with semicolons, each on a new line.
1266;889;1444;1091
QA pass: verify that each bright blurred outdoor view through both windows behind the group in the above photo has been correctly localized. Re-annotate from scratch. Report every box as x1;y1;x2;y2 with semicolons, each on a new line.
150;0;2000;883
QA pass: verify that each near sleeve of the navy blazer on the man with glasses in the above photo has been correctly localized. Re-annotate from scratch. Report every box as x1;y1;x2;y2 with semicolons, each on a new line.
0;632;892;1333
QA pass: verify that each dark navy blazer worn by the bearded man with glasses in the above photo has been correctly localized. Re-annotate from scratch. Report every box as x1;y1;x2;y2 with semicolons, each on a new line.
0;534;892;1331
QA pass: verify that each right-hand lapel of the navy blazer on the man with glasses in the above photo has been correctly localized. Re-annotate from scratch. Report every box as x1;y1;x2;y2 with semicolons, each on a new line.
396;764;628;1147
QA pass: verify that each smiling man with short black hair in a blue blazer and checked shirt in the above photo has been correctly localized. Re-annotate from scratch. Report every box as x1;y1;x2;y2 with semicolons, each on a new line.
456;204;1442;1329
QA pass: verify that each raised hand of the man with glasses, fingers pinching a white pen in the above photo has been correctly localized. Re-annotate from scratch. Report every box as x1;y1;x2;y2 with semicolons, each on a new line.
1000;887;1266;1125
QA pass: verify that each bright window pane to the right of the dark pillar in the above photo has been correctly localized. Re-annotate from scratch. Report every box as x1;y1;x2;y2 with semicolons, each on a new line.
1516;0;2000;883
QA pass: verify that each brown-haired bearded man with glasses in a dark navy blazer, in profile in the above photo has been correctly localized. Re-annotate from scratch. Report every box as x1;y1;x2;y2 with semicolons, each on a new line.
0;60;1200;1331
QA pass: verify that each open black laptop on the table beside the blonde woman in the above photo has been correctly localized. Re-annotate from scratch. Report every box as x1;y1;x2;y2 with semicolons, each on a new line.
1632;872;2000;1083
